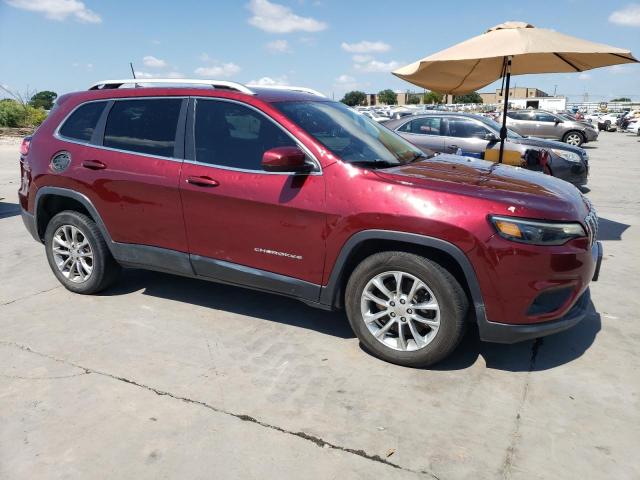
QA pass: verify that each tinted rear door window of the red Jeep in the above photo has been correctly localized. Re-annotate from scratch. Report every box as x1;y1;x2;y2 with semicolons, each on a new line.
103;98;182;157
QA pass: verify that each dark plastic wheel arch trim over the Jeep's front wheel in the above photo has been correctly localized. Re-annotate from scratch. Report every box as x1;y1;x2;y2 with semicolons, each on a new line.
320;230;486;320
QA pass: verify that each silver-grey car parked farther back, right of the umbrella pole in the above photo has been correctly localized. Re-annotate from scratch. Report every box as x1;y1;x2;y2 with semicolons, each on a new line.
507;110;598;147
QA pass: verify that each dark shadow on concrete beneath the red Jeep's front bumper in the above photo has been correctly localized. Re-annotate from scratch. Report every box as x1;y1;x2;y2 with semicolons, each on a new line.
431;302;602;372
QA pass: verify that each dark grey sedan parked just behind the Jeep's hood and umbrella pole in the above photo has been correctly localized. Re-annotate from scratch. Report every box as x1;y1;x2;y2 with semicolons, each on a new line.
385;112;589;186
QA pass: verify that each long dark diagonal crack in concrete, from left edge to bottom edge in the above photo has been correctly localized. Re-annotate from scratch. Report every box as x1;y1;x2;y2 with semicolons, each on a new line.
0;340;439;480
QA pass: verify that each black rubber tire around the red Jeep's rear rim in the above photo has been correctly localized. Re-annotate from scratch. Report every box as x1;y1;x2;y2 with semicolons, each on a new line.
44;210;120;295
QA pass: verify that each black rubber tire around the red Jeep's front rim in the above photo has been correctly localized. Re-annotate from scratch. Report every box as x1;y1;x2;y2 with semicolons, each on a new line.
345;252;469;367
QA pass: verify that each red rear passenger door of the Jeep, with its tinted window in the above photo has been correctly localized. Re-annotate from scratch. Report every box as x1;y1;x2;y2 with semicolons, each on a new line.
58;97;187;252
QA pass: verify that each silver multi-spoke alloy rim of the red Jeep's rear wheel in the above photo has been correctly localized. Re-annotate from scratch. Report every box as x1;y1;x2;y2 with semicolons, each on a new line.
51;225;93;283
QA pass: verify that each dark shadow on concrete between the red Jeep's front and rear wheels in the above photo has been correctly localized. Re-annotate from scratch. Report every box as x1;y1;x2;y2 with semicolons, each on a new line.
99;269;355;339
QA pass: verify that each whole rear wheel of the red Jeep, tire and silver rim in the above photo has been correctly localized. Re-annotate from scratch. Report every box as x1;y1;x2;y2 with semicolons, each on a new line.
44;210;120;295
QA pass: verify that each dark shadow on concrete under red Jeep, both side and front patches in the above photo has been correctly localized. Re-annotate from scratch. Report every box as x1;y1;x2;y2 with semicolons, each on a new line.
104;269;601;372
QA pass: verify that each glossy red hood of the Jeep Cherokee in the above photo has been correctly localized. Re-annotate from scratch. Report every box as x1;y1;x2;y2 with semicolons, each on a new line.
375;154;588;221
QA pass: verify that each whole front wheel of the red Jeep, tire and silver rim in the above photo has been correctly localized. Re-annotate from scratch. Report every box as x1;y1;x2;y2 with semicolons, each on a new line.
345;252;468;367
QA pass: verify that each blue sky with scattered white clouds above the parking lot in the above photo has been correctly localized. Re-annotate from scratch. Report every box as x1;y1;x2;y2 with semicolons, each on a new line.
0;0;640;101
